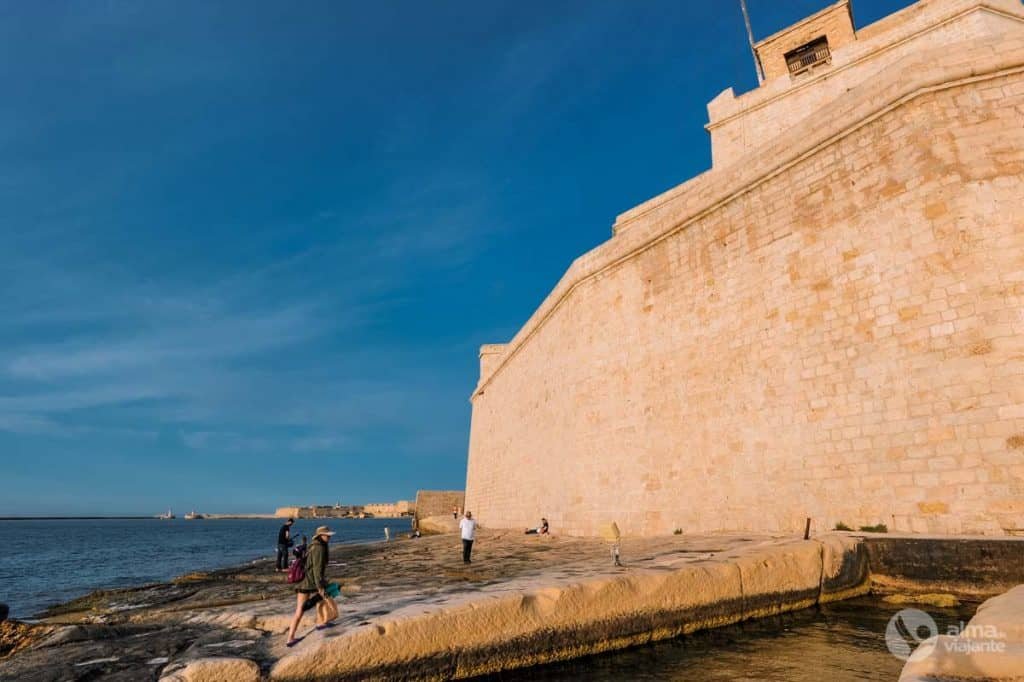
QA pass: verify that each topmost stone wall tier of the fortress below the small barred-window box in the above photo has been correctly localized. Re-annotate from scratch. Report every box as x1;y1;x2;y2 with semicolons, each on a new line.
708;0;1024;167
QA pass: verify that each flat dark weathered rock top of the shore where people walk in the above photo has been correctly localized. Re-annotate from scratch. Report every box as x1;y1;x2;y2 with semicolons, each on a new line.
0;532;847;682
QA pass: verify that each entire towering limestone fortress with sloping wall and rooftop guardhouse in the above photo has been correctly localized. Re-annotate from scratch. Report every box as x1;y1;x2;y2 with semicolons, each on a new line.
466;0;1024;535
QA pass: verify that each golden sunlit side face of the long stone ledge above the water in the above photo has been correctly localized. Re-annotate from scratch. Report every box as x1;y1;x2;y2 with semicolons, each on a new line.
271;541;855;682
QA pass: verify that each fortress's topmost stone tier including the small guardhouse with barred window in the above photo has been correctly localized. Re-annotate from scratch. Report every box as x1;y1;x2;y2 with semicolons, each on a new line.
700;0;1021;169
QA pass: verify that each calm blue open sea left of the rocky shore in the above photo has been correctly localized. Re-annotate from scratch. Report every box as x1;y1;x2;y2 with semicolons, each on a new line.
0;518;410;619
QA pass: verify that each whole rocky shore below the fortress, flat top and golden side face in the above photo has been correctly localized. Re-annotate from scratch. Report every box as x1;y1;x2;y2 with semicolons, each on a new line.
0;530;1019;682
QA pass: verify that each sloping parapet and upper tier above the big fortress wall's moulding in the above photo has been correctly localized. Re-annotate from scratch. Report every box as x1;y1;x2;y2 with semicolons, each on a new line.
471;0;1024;399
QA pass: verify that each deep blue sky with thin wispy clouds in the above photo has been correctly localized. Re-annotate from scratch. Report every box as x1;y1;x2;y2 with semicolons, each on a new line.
0;0;908;515
